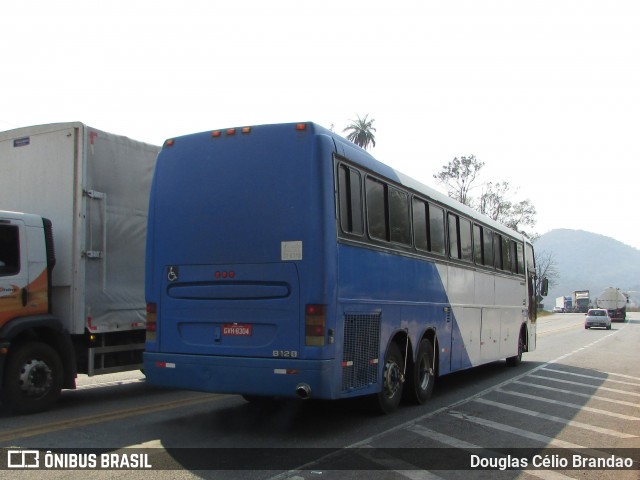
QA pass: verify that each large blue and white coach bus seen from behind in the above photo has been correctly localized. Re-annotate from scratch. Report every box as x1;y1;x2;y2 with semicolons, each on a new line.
144;123;537;413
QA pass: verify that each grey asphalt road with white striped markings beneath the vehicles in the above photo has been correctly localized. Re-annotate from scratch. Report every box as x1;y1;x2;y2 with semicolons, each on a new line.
0;313;640;480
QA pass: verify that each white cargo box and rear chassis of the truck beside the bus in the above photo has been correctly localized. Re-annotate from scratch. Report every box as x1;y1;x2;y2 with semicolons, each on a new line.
0;122;160;412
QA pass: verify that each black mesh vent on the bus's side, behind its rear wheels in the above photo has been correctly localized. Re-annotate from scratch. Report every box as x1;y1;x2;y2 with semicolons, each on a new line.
342;313;380;392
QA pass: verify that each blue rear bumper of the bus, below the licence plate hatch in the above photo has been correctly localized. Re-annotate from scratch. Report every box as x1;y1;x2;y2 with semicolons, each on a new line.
144;352;342;400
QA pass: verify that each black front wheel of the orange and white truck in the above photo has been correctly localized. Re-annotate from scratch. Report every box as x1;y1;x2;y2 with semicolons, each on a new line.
2;342;63;413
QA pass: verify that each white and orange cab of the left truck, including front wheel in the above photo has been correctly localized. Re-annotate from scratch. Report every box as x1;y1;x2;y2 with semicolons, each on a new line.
0;211;75;413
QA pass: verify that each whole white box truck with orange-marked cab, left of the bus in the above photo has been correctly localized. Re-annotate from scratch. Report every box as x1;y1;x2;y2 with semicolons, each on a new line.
0;122;160;413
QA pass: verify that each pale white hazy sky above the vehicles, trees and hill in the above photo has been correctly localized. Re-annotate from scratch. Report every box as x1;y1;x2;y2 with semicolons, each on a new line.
5;0;640;248
